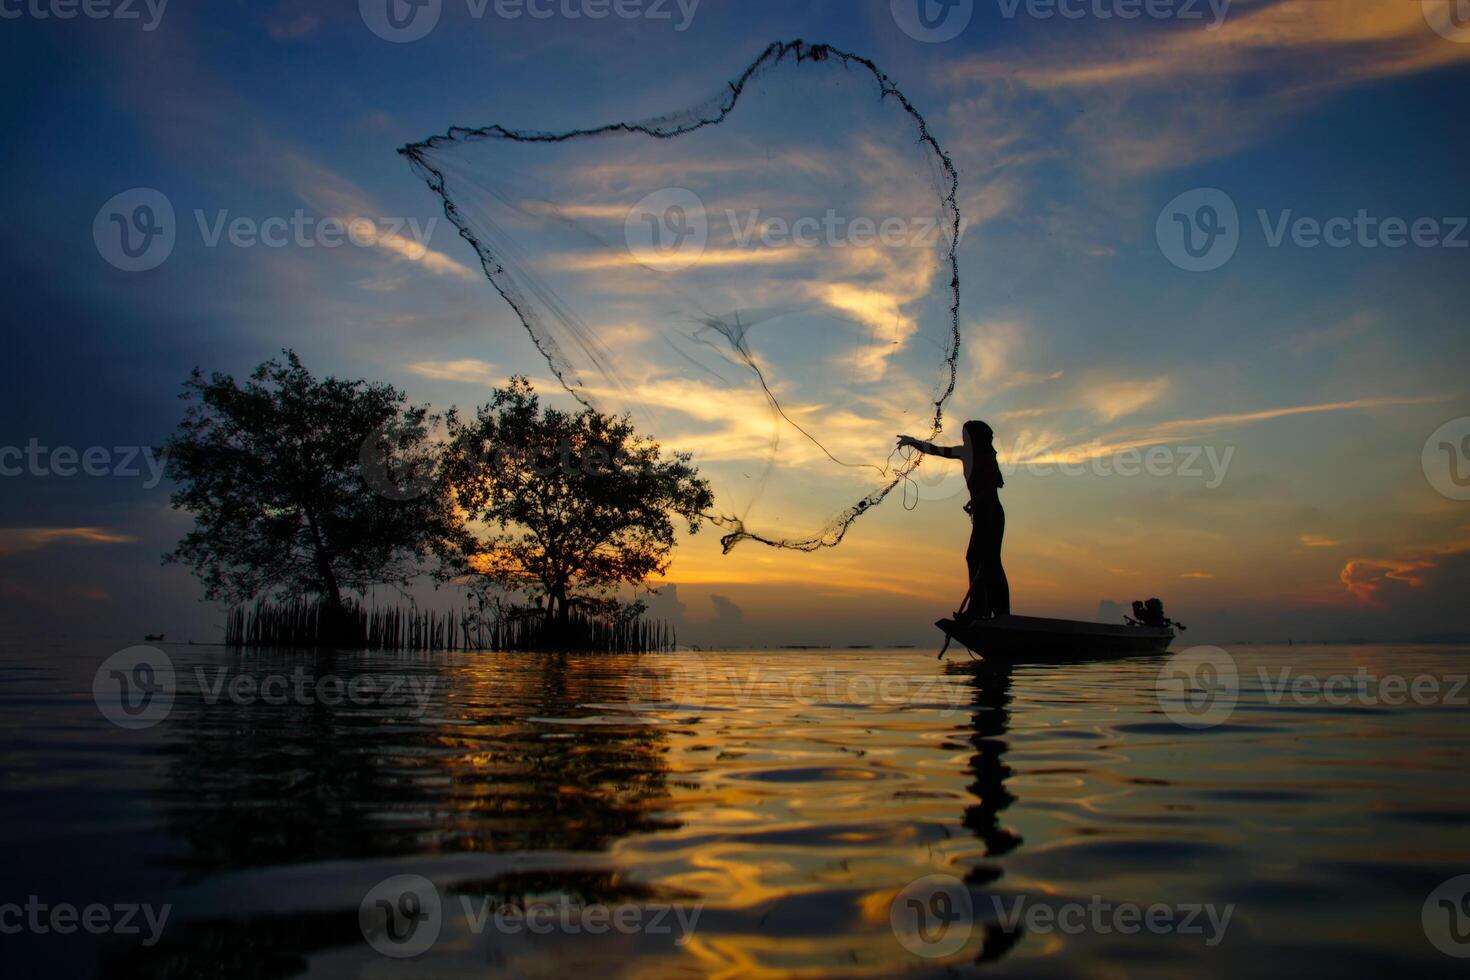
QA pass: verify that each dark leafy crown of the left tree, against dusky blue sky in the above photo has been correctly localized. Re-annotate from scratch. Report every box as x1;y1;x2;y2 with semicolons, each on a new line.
165;350;453;610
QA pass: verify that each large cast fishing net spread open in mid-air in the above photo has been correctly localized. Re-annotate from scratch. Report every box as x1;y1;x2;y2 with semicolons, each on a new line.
400;41;963;551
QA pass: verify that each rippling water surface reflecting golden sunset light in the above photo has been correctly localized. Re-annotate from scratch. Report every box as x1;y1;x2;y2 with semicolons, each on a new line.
0;646;1470;979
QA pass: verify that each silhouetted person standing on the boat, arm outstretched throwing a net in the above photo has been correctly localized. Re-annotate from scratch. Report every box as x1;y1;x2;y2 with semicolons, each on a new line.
898;420;1010;619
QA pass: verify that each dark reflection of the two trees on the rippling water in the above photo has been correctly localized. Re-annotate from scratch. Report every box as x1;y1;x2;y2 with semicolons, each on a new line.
111;654;669;980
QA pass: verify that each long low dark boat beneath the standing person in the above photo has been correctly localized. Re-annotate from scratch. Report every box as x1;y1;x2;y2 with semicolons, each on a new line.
935;616;1175;660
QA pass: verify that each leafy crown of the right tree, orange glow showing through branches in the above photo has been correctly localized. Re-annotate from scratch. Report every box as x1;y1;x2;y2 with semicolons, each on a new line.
441;376;713;616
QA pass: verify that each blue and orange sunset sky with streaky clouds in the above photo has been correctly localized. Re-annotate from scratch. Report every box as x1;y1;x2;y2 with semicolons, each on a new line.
0;0;1470;646
